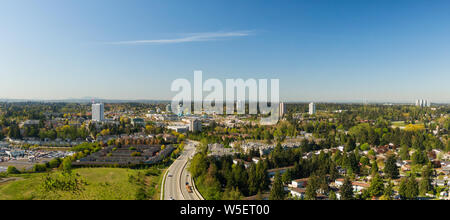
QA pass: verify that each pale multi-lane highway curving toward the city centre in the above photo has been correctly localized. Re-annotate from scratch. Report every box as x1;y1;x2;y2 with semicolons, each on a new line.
161;141;203;200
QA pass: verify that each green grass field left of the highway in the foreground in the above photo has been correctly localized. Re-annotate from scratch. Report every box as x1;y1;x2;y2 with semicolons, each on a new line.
0;168;164;200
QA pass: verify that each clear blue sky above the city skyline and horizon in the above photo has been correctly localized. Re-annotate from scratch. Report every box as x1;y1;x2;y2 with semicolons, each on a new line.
0;0;450;103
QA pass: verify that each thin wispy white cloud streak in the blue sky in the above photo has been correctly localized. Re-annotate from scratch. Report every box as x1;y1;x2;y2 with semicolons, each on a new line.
107;31;253;45
